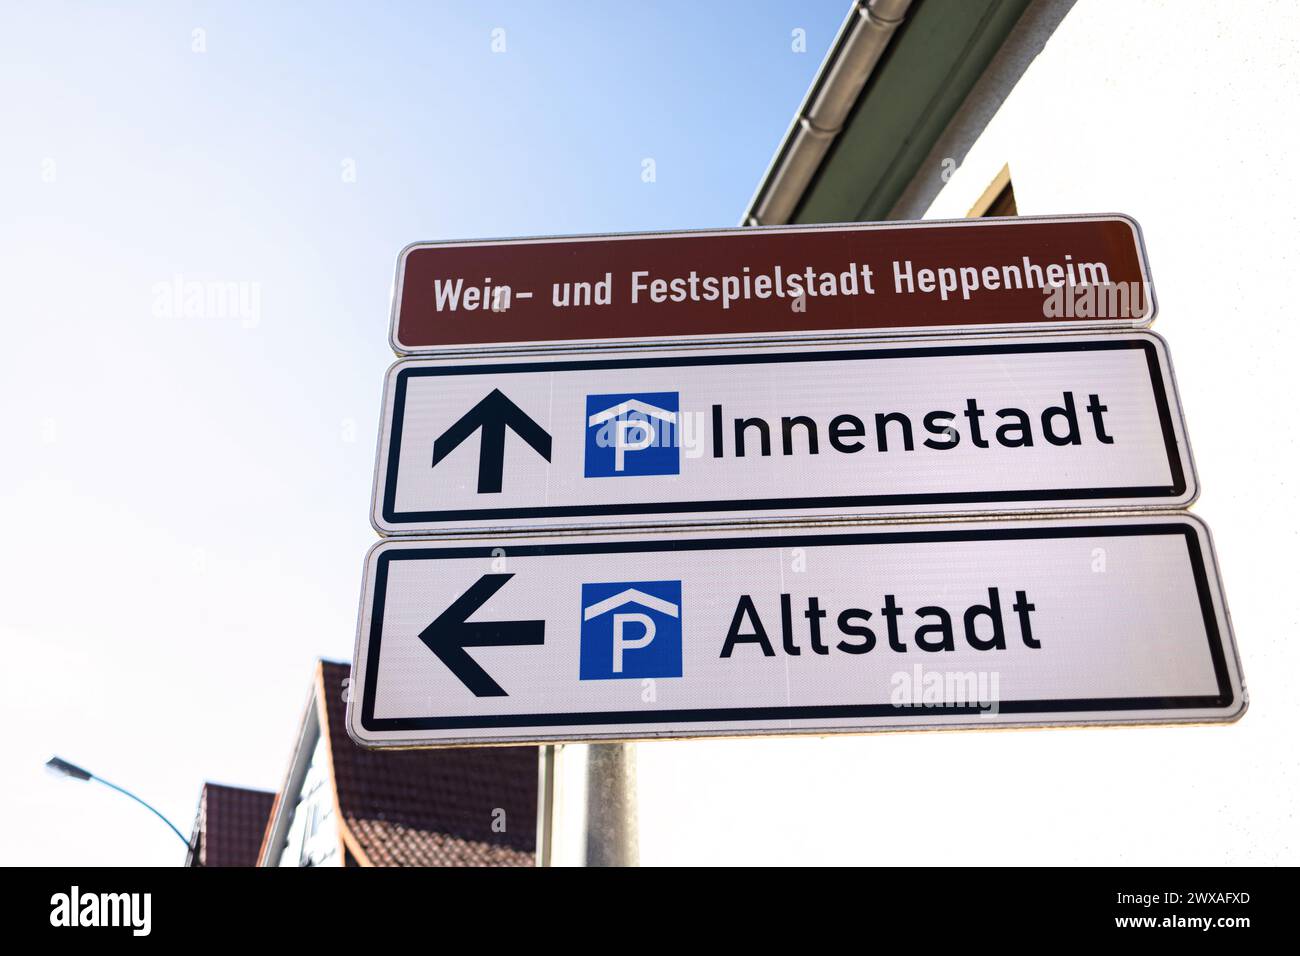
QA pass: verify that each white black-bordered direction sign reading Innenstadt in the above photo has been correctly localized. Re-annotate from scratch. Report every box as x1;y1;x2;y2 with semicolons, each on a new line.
372;332;1196;535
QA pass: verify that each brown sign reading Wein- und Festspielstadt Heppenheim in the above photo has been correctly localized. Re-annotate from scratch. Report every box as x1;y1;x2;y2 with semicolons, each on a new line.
390;215;1156;354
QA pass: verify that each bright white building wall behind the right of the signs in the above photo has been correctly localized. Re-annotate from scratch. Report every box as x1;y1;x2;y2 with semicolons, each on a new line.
637;0;1300;865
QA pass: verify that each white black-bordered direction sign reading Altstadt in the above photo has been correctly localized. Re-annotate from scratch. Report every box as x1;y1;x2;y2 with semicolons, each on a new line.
347;514;1245;747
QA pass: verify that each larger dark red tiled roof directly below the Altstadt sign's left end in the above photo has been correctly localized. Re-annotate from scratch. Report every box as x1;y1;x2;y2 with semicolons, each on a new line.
321;661;537;866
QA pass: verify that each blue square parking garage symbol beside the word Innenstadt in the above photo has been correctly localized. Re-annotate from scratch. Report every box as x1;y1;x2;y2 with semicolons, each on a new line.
584;392;681;477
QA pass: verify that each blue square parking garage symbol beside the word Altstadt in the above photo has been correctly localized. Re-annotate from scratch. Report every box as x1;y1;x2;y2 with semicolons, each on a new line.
579;581;681;680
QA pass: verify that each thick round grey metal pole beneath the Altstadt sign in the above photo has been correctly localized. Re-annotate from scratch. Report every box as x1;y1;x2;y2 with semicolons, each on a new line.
585;744;641;866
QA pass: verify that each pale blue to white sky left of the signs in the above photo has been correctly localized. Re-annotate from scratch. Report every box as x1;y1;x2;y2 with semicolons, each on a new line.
0;0;848;864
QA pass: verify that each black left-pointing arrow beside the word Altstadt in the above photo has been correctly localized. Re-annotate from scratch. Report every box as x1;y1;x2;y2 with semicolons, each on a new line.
420;574;546;697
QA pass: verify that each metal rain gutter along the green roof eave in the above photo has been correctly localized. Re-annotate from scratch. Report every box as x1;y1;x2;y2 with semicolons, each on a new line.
741;0;911;226
